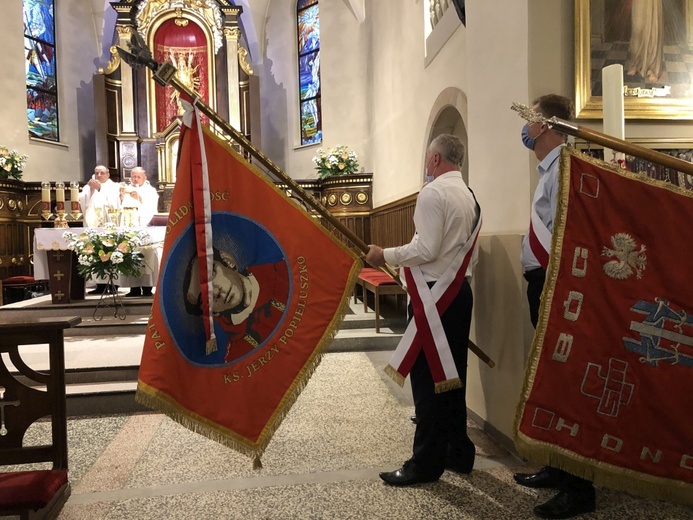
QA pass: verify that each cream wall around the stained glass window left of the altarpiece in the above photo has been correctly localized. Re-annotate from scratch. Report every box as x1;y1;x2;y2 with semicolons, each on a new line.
0;0;101;181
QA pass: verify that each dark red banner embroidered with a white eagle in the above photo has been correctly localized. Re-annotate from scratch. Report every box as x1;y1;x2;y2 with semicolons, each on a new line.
516;149;693;503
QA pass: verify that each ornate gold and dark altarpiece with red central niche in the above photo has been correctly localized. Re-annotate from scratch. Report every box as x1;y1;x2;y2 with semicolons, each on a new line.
99;0;252;211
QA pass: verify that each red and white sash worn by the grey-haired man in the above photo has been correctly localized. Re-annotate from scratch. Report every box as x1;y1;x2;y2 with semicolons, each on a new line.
385;205;481;393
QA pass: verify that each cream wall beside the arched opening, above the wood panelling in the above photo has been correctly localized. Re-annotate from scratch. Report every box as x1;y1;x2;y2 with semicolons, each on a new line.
366;0;467;206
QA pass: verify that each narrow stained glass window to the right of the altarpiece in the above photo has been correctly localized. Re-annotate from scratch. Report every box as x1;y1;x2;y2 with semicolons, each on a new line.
296;0;322;144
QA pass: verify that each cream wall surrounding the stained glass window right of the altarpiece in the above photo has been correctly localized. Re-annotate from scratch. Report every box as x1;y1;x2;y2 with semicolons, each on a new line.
257;0;371;179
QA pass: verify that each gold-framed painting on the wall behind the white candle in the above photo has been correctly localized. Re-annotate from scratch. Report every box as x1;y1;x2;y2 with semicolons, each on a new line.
575;0;693;119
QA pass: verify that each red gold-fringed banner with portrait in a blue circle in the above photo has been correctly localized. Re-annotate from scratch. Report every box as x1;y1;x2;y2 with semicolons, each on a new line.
137;117;361;458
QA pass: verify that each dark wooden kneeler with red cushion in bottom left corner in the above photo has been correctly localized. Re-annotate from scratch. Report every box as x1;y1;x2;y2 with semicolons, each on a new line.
0;313;82;519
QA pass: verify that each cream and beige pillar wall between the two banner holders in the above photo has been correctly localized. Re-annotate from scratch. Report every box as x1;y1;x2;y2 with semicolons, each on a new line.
467;0;532;444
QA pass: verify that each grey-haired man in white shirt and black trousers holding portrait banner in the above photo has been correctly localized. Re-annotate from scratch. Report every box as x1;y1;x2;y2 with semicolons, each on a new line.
366;134;481;486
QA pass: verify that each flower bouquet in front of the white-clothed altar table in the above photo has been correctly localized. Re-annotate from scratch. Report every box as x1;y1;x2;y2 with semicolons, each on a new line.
63;224;151;283
